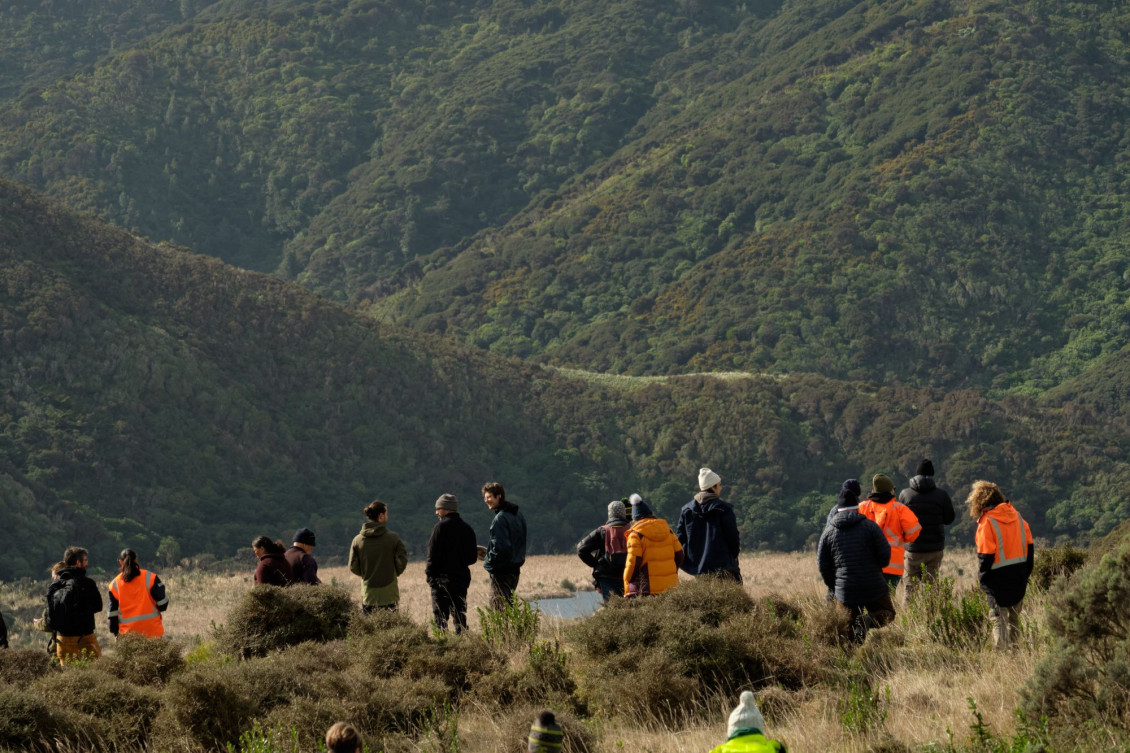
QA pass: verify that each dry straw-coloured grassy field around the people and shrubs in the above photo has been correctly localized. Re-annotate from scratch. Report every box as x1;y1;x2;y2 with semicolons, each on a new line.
0;549;1049;753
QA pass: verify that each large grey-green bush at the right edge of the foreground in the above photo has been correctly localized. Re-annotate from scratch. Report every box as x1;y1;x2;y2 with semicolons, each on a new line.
1023;542;1130;734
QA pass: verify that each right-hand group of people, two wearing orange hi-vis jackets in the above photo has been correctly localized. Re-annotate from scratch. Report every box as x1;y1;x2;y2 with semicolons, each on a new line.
816;459;1035;649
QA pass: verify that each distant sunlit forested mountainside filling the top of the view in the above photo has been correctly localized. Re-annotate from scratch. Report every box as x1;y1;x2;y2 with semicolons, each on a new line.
0;0;1130;388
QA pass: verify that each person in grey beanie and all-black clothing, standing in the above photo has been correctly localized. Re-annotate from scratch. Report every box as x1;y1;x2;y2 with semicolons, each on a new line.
424;494;479;634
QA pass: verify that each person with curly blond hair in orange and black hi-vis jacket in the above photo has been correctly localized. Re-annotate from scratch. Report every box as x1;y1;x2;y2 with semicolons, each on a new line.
965;481;1035;649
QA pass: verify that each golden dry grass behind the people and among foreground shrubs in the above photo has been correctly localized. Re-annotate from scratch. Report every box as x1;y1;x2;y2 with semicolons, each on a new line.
0;549;1046;753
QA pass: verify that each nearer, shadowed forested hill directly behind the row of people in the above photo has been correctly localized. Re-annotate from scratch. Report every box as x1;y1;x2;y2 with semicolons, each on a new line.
0;181;1130;579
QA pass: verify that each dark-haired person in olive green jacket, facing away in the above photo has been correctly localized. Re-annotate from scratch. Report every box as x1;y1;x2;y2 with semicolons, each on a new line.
349;500;408;614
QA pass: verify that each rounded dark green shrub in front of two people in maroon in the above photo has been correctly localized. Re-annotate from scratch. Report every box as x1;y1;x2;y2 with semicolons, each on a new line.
216;586;357;658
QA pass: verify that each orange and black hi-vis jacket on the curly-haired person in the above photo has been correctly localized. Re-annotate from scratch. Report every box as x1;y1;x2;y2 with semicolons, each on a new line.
975;502;1035;607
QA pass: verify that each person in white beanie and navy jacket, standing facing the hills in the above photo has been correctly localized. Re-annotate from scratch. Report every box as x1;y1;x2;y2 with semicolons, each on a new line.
676;468;741;583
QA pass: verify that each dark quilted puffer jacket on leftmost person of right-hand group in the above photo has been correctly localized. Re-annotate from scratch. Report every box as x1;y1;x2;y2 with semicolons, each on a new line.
816;508;890;606
